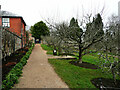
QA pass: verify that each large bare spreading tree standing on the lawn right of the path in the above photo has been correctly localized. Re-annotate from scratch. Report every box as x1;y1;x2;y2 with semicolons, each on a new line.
43;14;104;63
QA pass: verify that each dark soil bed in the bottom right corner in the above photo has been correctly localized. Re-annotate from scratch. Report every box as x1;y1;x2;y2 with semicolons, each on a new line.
91;78;120;90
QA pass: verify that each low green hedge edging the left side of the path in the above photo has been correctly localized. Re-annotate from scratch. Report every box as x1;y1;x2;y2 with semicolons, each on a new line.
2;44;34;90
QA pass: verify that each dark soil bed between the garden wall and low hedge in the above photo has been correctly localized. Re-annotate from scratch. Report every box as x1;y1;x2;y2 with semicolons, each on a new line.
2;47;28;80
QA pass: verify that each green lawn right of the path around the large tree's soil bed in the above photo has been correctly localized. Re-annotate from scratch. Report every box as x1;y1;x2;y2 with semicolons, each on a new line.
49;55;112;88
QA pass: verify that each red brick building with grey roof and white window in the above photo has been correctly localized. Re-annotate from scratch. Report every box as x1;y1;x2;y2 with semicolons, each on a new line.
0;11;26;47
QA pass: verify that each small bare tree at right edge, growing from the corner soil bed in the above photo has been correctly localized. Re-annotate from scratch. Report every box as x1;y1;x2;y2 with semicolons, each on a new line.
99;15;120;85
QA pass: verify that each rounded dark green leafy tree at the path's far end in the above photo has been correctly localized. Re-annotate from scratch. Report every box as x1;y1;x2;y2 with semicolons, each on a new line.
30;21;49;39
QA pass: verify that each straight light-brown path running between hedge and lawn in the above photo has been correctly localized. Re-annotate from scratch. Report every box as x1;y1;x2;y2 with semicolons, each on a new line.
14;44;68;88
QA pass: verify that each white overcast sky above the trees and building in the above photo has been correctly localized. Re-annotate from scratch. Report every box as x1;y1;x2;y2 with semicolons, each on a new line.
0;0;120;26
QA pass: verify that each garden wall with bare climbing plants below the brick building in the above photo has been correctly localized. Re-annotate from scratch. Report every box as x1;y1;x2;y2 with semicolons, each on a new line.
1;28;22;59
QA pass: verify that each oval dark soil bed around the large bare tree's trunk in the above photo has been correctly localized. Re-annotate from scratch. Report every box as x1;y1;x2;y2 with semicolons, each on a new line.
70;61;98;69
